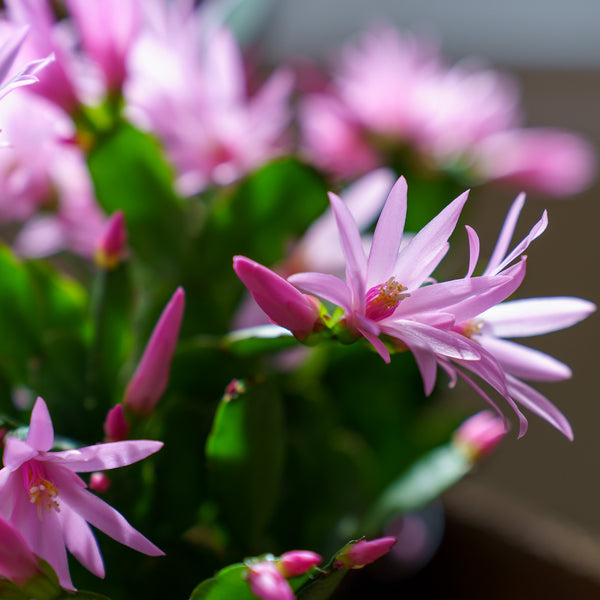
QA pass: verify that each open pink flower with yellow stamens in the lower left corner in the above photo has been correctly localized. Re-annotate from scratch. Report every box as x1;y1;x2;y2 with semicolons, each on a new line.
0;398;162;589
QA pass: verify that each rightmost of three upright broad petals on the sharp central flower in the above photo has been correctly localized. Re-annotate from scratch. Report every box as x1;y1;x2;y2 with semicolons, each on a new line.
394;192;469;289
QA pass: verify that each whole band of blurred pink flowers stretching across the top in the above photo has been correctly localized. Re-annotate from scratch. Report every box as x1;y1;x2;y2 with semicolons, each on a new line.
0;0;594;256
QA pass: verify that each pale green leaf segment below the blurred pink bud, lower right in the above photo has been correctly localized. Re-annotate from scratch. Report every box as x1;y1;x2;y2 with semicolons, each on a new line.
360;442;473;535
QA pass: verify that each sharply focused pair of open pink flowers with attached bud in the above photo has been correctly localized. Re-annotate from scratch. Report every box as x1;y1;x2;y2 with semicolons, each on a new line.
234;178;595;439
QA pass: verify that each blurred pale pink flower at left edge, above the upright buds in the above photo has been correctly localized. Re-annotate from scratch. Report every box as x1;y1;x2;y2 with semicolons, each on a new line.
0;93;104;257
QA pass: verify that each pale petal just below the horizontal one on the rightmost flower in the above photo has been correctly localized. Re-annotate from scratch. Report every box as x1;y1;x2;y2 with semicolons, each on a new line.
477;335;572;381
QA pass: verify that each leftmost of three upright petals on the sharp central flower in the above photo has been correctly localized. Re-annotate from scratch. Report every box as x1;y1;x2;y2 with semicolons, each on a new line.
329;193;367;313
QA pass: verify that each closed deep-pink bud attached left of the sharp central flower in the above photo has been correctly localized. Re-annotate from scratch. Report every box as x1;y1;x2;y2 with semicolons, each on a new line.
233;256;320;341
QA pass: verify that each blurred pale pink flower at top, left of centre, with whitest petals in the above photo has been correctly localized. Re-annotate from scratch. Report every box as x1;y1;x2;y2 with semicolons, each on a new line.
125;7;293;195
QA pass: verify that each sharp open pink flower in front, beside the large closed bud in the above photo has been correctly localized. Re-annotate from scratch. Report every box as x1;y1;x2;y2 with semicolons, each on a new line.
289;178;514;362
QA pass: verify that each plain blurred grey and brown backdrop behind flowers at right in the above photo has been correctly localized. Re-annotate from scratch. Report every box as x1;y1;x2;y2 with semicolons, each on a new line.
263;0;600;584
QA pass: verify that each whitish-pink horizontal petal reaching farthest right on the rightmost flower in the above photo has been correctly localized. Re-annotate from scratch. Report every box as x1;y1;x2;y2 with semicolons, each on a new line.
481;296;596;337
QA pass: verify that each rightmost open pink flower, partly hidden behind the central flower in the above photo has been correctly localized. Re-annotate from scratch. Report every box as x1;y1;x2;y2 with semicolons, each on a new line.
434;194;596;439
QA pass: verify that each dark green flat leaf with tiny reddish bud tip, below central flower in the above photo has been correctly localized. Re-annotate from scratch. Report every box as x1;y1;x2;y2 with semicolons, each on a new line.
206;383;284;552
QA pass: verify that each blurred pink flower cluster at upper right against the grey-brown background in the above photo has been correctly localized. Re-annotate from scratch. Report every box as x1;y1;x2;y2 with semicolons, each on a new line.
300;28;594;196
